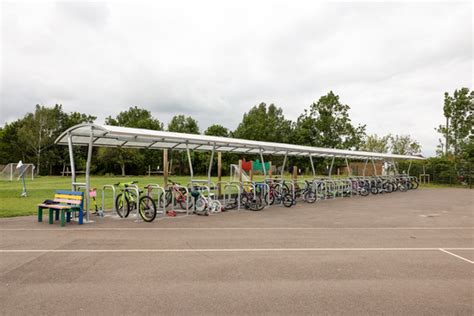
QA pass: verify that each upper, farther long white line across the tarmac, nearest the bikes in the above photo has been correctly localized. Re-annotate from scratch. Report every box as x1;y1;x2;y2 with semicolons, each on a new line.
0;227;474;232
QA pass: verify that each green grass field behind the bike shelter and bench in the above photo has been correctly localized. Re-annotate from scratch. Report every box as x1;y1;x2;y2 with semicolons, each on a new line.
0;176;465;217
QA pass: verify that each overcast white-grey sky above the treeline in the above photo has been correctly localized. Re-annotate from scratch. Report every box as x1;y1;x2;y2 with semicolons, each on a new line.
0;0;474;155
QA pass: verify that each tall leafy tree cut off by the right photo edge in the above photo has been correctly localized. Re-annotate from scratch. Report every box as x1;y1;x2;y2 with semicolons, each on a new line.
436;88;474;159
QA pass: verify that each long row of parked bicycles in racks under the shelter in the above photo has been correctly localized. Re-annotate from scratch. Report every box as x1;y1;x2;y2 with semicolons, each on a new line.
101;175;419;222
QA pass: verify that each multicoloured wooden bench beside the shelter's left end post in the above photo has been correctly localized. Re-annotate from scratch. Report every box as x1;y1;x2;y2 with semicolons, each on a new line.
38;190;84;227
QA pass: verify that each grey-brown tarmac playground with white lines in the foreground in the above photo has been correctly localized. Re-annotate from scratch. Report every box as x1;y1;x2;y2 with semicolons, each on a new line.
0;189;474;315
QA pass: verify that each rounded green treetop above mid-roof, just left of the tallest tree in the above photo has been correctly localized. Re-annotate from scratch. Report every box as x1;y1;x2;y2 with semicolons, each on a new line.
233;103;291;143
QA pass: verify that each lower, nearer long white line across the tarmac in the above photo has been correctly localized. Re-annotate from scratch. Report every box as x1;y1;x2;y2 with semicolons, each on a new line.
0;248;474;253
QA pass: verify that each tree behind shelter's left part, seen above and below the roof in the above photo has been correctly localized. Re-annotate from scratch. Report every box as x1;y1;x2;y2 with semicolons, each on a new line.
103;106;163;176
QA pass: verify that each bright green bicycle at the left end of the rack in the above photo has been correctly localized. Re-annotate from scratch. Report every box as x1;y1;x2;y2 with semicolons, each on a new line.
115;181;156;222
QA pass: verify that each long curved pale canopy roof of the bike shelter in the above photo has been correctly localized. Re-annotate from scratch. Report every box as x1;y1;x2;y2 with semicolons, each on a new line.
56;124;424;159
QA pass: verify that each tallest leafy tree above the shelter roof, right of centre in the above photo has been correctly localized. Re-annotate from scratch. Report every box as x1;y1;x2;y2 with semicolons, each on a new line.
292;91;365;149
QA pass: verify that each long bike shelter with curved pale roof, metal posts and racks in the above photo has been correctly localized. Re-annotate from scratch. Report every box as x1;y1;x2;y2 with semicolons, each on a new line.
55;123;424;223
